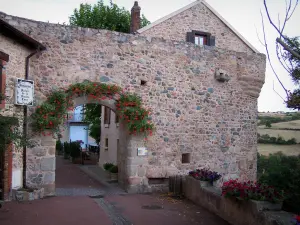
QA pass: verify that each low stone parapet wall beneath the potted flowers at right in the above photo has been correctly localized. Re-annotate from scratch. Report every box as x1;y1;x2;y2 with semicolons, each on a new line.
183;176;293;225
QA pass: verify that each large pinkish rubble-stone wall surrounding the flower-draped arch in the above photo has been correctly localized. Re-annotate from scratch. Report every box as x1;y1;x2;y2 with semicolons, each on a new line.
0;11;265;192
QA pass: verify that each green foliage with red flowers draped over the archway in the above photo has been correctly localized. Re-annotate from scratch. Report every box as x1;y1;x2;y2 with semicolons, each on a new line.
31;82;154;136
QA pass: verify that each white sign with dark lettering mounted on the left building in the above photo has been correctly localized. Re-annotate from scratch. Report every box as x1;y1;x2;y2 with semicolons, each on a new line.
15;78;34;106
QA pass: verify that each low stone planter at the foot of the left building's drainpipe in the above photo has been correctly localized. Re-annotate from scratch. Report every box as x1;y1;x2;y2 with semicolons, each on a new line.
12;188;44;202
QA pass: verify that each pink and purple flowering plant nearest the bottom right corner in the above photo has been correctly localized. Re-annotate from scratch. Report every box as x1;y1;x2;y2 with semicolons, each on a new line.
222;180;284;203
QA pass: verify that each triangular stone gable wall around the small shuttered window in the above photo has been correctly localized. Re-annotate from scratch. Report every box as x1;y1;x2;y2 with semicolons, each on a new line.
141;3;253;53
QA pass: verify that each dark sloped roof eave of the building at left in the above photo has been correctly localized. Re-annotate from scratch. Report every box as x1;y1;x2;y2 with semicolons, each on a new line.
0;19;46;50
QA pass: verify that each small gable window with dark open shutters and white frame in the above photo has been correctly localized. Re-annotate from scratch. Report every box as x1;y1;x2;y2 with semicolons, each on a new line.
186;30;215;46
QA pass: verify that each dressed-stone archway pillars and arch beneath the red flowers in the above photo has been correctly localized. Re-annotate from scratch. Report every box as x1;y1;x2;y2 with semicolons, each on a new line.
26;83;149;196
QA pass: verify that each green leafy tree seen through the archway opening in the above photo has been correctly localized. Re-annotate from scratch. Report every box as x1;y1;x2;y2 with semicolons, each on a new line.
84;104;101;144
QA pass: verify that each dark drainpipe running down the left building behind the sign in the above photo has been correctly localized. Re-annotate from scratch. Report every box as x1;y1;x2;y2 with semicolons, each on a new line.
23;48;39;188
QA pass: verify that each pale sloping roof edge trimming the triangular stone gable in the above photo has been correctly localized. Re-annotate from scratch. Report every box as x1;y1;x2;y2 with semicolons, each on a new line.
137;0;259;53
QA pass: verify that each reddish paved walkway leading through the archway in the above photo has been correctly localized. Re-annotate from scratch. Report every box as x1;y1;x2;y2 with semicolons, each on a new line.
0;158;228;225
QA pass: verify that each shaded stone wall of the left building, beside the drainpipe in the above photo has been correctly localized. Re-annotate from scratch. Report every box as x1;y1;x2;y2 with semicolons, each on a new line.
0;34;31;191
